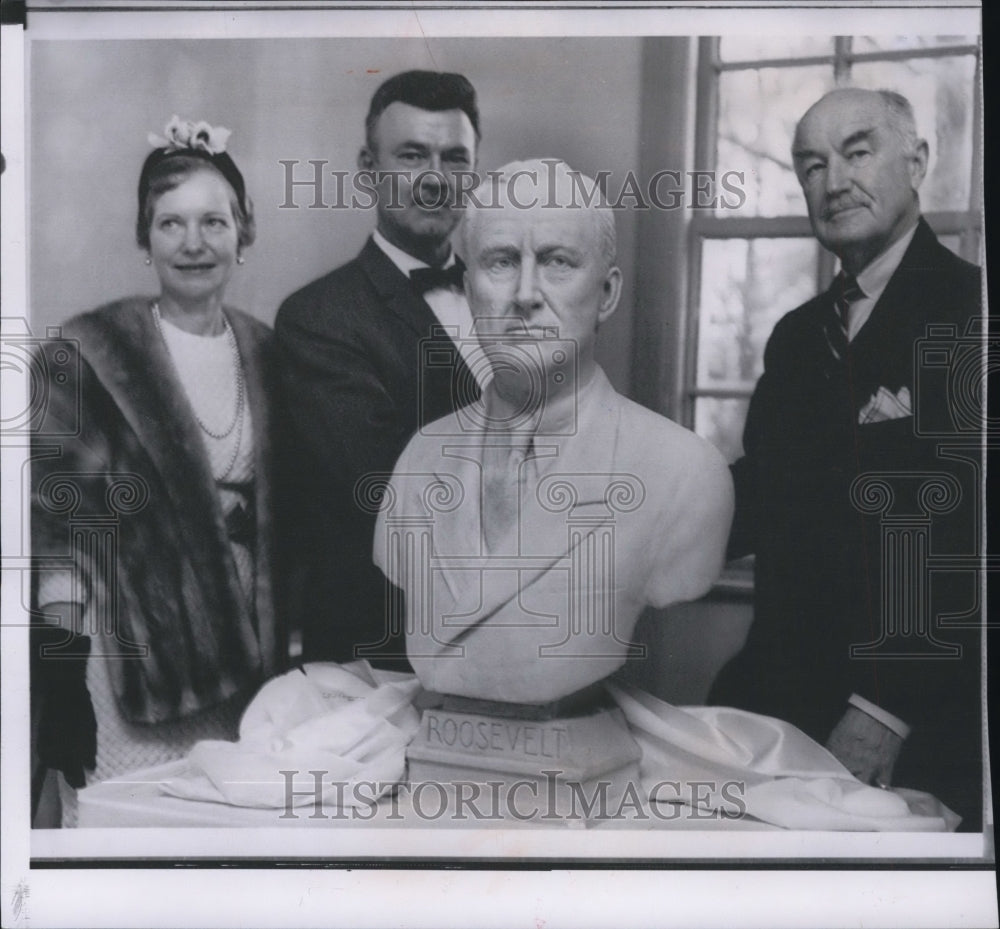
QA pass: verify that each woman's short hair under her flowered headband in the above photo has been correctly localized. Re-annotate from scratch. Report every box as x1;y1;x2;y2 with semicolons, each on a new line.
135;148;257;249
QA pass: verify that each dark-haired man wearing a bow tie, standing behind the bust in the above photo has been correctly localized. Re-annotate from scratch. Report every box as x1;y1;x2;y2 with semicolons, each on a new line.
275;71;479;668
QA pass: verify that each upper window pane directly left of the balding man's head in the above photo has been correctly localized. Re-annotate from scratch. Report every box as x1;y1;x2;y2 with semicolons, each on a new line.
716;66;834;216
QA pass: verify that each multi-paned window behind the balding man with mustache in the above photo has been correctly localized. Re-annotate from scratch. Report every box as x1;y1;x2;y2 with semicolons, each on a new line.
679;36;982;461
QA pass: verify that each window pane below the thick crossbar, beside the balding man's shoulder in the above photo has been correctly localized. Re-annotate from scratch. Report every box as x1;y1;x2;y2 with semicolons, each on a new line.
696;239;819;389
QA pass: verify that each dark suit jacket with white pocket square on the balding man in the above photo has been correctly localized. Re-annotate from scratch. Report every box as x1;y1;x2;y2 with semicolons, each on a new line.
710;220;982;825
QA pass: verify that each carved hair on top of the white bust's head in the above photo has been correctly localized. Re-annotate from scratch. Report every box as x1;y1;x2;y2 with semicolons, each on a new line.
459;158;618;268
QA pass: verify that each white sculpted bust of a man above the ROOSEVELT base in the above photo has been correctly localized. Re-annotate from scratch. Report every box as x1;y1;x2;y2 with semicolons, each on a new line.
374;159;733;704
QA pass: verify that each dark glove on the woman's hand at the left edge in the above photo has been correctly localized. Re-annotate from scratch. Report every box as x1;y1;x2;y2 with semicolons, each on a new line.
31;626;97;788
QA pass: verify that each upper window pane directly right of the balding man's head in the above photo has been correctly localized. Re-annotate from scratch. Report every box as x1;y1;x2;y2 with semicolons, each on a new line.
851;55;976;212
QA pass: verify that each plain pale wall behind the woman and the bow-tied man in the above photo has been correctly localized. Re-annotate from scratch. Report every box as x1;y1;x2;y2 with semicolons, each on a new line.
29;38;642;391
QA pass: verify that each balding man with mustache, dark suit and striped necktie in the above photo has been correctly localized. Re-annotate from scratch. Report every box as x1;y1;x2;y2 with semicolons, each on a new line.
710;88;982;829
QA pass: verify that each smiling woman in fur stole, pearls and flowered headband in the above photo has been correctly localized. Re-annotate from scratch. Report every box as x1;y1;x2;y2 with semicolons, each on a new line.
32;117;286;825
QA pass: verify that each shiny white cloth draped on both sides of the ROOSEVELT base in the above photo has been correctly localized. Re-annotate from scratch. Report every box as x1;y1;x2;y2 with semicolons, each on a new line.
160;661;958;832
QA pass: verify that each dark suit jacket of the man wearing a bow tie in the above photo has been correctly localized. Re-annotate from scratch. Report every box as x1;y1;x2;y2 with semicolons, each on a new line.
275;239;478;668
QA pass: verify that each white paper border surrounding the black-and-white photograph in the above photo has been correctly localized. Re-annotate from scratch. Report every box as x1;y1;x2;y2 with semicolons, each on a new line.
0;0;997;927
